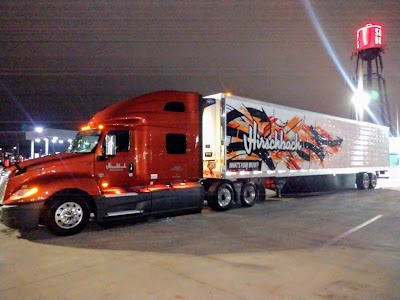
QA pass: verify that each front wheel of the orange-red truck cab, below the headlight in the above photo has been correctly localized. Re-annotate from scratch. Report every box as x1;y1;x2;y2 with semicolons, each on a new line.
45;195;90;236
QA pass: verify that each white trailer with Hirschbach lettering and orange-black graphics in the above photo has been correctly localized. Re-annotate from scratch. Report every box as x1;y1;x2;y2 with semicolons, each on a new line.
202;93;389;203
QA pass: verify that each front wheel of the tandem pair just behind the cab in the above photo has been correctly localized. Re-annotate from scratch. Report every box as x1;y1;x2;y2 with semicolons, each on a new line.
207;182;235;211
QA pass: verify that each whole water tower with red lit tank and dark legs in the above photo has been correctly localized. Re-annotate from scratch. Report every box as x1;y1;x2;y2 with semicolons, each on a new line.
354;24;392;134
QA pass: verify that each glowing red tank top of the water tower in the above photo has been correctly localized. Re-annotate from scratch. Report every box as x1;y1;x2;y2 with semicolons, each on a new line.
357;24;383;52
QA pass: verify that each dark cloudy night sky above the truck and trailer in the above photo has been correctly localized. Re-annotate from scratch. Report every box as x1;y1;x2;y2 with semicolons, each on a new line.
0;0;400;131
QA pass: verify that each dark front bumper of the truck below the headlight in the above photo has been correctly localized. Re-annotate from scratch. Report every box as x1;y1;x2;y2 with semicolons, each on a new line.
0;202;43;230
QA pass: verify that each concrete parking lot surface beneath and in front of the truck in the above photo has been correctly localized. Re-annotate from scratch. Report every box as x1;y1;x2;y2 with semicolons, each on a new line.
0;175;400;300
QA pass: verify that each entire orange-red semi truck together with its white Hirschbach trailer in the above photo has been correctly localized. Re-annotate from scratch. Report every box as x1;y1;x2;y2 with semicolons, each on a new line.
0;91;389;236
